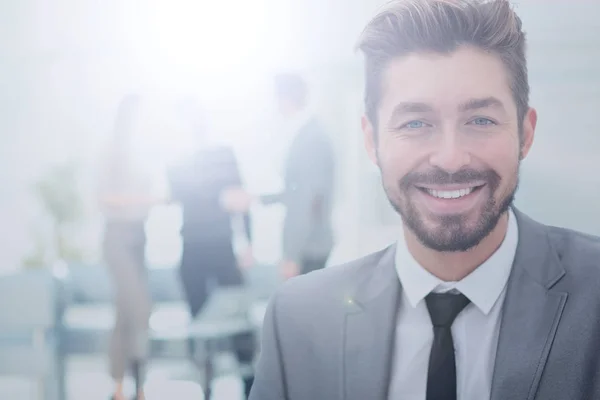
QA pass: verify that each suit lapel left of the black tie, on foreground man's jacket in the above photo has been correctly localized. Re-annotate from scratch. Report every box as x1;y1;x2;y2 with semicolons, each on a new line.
343;247;400;400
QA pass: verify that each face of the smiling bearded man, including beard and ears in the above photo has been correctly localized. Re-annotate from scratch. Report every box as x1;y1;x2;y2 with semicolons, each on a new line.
363;47;536;251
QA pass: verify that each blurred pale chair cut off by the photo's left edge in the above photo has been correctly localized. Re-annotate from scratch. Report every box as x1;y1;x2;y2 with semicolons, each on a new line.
0;269;64;400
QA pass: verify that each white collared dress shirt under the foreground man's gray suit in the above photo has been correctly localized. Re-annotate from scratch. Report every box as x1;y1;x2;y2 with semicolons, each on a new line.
389;210;519;400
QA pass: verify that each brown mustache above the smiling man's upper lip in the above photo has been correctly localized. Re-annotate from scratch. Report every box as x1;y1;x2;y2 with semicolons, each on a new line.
399;168;500;189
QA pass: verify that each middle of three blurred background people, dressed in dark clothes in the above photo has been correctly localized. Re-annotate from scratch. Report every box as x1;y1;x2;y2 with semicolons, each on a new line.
168;96;254;394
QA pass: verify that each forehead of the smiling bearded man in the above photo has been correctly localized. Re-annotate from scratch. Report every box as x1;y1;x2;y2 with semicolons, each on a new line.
380;47;516;115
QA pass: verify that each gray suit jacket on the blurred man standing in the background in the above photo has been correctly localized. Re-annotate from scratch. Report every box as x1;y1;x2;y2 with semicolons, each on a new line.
261;119;334;262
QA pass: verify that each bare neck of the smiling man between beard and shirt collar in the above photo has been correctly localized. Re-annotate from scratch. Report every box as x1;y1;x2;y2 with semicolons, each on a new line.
404;212;508;282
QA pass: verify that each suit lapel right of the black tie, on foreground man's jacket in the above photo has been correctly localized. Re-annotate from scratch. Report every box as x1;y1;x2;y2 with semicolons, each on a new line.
491;210;567;400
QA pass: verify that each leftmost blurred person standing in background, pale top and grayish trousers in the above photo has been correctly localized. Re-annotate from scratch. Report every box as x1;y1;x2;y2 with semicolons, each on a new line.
98;95;163;400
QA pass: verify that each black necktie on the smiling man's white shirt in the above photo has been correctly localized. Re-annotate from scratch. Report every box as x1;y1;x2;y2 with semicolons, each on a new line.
425;293;469;400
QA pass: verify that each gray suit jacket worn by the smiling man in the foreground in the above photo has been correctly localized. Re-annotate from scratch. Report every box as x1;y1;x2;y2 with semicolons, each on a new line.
250;210;600;400
